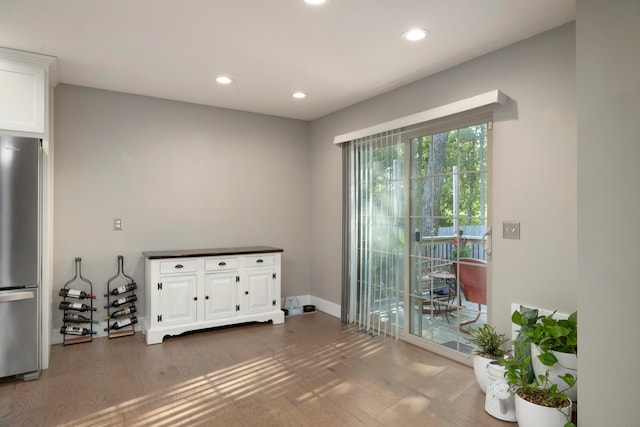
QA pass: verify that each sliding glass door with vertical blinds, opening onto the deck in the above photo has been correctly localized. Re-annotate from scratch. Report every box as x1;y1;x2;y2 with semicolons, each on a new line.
343;116;490;353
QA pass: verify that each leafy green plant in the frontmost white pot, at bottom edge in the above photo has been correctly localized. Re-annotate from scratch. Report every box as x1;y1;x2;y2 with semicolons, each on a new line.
499;309;577;427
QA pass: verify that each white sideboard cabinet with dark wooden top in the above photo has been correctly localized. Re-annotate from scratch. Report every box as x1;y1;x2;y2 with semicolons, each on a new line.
143;246;284;344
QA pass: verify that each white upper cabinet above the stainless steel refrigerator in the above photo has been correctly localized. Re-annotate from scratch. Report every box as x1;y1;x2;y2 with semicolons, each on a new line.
0;48;57;135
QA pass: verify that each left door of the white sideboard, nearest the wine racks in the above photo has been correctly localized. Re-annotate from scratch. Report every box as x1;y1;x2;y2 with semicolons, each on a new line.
156;274;197;326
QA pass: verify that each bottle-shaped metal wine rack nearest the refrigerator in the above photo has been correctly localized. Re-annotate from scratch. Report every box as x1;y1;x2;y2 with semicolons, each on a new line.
59;258;97;345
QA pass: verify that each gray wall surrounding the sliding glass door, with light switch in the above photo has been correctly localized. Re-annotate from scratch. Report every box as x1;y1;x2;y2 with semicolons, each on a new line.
311;23;577;340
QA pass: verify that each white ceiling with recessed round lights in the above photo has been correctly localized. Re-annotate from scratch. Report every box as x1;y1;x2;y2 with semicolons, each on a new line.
0;0;575;120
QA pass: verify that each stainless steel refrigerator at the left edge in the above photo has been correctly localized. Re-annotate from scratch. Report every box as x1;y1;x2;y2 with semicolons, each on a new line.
0;135;41;381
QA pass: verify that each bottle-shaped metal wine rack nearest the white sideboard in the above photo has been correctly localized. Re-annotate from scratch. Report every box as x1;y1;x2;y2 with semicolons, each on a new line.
104;255;138;338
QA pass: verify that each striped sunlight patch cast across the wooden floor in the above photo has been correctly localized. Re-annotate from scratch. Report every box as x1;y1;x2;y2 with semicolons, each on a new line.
63;333;400;427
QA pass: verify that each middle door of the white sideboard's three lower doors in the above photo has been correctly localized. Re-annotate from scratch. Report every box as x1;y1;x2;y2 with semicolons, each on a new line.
204;271;238;320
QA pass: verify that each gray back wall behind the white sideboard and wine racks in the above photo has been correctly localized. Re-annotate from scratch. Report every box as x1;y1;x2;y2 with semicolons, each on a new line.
53;84;311;327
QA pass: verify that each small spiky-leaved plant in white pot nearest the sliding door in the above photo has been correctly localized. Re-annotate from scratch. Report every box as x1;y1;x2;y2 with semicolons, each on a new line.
467;324;509;393
